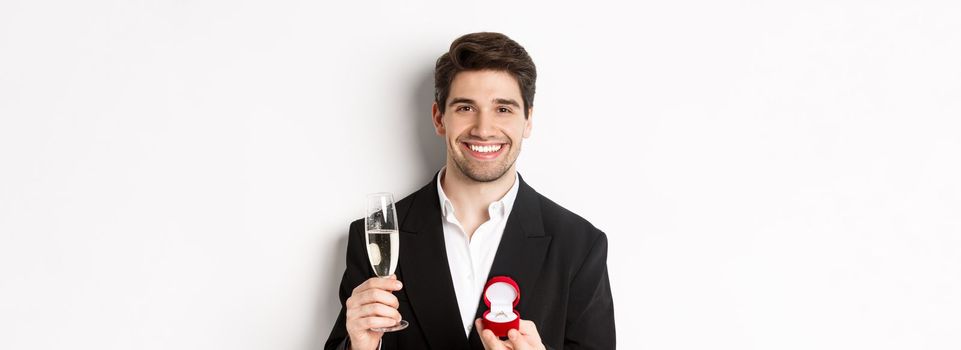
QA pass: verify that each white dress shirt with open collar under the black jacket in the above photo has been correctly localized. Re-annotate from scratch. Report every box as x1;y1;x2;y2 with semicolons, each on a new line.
437;168;520;336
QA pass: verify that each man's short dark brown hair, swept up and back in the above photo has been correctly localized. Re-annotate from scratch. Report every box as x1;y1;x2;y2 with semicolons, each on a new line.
434;32;537;118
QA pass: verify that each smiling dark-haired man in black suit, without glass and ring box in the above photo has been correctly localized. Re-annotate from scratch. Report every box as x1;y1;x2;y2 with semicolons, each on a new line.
326;33;615;350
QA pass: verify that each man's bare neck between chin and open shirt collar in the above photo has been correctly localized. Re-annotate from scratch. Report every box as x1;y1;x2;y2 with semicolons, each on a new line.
441;162;517;216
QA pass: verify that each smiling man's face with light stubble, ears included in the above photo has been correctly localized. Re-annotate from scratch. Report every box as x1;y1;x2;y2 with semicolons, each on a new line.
433;70;533;182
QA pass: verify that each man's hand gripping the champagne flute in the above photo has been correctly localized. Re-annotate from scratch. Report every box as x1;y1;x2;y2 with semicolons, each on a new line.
346;275;403;350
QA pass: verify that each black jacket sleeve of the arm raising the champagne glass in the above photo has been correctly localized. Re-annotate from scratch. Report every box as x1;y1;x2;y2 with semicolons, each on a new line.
324;220;373;350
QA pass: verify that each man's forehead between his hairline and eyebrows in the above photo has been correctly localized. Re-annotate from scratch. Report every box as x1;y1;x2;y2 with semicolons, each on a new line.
448;70;521;102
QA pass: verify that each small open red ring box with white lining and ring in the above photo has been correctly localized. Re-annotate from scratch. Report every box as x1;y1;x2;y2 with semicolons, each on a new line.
481;276;521;337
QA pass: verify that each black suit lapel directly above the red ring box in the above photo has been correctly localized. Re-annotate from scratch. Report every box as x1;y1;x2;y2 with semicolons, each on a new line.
470;174;551;348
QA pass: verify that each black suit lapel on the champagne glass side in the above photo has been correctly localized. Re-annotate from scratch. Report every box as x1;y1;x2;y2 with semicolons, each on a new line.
399;178;467;349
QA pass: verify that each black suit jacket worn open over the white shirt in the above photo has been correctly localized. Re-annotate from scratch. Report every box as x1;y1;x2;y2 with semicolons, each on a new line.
325;177;615;350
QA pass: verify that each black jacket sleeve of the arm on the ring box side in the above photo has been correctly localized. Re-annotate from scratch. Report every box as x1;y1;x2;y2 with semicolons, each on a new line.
564;229;615;350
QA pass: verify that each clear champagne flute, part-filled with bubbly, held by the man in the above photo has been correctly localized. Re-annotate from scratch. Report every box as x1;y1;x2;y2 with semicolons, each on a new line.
364;193;408;332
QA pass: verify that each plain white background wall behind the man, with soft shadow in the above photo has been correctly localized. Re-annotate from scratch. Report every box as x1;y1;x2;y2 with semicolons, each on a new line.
0;0;961;350
